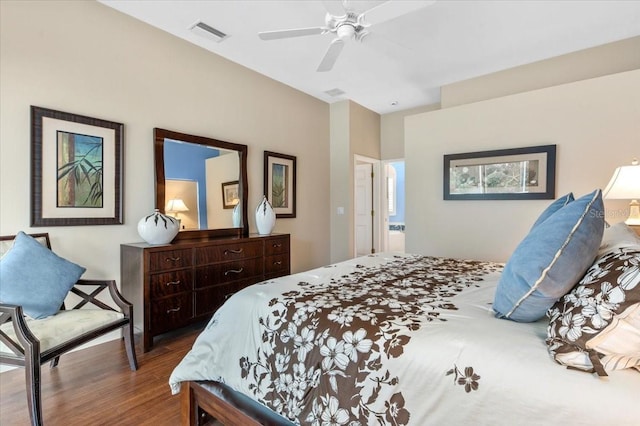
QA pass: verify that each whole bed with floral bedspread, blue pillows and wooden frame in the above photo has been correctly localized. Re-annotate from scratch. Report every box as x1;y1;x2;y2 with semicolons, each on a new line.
169;189;640;426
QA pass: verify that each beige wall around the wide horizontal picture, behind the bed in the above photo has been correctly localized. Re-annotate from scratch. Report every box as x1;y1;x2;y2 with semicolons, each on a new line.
405;70;640;261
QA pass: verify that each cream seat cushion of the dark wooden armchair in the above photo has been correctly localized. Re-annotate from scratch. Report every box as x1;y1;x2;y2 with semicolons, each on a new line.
0;309;124;352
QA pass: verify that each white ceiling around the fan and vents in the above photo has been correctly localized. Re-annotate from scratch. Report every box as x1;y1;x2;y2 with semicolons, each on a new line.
100;0;640;114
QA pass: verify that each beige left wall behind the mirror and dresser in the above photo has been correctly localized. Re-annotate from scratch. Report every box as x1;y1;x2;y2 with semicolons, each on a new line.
0;1;330;278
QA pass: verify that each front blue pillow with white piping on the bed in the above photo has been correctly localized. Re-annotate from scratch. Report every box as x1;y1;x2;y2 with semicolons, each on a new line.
493;189;604;322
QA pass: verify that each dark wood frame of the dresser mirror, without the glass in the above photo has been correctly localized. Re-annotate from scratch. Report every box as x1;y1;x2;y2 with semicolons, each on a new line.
153;128;249;241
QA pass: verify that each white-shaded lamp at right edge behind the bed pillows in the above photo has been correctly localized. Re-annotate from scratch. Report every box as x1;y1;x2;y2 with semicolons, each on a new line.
603;158;640;226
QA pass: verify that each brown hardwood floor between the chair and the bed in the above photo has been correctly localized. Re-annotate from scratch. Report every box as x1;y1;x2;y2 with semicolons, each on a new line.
0;324;204;426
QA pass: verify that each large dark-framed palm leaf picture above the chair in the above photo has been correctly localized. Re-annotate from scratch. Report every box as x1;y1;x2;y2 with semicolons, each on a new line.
31;106;124;226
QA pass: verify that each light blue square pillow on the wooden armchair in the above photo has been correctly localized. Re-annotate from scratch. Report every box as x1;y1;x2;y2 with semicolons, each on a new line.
0;231;86;318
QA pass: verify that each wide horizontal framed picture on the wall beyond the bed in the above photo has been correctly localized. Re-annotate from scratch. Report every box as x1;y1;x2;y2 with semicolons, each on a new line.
443;145;556;200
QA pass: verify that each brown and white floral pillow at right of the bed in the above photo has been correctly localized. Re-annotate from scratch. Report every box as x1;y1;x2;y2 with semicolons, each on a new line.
546;245;640;376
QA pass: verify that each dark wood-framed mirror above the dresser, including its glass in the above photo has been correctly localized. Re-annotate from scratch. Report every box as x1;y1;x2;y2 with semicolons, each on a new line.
153;128;249;240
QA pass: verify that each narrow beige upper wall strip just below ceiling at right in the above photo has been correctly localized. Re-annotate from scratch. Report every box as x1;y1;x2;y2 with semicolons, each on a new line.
440;36;640;108
